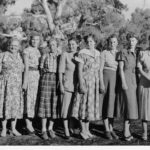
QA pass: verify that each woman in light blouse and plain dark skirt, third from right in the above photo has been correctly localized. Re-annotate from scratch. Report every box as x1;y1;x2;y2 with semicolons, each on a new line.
100;35;118;140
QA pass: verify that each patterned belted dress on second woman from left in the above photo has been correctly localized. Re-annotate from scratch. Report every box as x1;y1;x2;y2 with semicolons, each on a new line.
23;47;41;118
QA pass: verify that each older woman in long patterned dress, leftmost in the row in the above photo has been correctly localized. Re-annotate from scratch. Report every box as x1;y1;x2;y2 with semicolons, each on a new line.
0;39;24;137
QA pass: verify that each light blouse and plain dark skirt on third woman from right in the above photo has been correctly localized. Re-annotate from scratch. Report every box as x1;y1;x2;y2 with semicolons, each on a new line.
101;50;118;119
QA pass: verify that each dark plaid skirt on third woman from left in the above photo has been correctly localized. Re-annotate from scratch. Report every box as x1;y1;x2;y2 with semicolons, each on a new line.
38;73;60;119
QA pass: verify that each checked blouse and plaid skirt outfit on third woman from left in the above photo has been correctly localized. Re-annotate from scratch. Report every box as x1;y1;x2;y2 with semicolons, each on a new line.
38;52;60;119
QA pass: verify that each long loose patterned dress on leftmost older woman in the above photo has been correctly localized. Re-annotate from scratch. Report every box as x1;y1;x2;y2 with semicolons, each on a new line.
0;52;24;119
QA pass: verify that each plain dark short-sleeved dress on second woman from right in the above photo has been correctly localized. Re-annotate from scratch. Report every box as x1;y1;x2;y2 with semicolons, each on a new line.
118;50;138;119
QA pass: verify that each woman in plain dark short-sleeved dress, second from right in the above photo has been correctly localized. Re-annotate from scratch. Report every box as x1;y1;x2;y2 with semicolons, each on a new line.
118;35;138;141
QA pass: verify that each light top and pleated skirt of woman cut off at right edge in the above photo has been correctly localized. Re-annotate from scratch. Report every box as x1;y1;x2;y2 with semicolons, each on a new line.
139;50;150;121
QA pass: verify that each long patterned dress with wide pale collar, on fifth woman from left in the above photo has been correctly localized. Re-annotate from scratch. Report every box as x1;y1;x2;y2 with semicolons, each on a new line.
72;49;101;121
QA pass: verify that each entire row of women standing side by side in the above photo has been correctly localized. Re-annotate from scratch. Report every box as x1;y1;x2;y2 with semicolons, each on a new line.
0;32;150;141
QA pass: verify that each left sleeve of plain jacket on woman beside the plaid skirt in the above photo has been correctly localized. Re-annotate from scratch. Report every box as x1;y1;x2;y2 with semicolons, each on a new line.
58;53;66;73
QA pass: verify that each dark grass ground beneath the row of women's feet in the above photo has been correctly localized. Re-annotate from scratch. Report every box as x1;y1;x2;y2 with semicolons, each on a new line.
0;120;150;146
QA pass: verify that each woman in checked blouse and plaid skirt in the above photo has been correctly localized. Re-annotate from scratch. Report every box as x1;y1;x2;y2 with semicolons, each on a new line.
38;39;60;140
